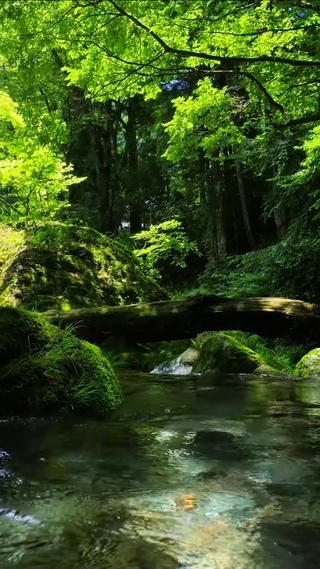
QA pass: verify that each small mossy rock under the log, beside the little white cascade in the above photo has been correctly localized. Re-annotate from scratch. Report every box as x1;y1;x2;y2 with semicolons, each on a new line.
192;332;265;373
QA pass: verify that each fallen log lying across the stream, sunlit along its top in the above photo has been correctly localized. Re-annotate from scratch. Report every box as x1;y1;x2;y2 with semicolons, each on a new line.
43;295;320;345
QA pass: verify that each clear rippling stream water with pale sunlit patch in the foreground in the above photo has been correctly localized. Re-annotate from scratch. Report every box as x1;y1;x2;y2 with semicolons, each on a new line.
0;375;320;569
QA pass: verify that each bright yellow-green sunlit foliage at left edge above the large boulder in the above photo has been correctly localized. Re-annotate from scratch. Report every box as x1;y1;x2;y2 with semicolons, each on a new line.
0;91;84;223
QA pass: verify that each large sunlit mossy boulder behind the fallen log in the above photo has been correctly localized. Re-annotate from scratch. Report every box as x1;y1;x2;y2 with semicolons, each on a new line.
0;223;166;311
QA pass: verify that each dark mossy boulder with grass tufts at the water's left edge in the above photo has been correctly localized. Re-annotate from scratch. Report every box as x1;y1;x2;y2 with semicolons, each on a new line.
0;307;122;416
